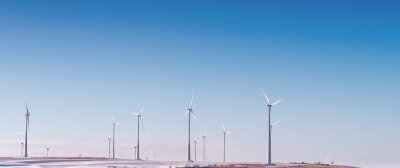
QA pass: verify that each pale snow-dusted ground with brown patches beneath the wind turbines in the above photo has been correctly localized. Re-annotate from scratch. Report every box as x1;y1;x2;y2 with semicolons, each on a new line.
0;158;354;168
